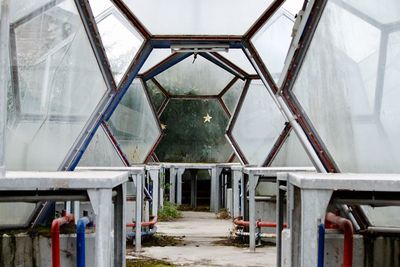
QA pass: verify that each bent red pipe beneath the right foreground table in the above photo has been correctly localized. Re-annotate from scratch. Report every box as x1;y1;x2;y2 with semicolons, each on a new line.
325;215;354;267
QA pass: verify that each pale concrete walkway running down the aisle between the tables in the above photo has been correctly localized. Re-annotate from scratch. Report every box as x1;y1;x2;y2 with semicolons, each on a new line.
128;211;276;267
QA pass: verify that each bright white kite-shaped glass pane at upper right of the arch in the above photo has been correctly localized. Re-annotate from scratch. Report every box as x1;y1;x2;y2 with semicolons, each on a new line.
251;8;293;82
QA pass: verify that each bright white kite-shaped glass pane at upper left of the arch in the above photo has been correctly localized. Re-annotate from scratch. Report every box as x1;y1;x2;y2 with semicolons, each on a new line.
90;0;144;84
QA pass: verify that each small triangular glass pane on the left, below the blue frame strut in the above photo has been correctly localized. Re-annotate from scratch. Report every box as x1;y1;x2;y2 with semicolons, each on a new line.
79;126;125;167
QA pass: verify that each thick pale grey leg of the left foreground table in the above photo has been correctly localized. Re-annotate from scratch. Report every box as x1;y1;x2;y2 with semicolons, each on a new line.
88;189;112;267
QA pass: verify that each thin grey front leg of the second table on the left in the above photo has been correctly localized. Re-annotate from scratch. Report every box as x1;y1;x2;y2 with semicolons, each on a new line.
135;174;144;252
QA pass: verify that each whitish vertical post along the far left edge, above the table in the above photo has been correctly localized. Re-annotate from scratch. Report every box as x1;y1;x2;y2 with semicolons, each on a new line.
0;0;10;178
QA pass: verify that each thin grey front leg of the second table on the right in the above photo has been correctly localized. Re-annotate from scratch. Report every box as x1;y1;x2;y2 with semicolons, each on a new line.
249;174;258;252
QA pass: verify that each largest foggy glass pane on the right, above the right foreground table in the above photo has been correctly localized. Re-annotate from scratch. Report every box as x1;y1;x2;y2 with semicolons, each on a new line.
293;2;400;173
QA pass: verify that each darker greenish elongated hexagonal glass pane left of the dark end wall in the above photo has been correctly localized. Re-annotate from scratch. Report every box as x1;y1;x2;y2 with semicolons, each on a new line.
109;79;161;164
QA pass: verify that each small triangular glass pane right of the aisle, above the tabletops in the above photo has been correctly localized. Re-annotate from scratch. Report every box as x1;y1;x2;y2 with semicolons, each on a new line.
270;130;314;167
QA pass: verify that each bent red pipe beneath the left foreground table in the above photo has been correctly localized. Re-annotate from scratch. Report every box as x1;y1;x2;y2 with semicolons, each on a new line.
51;211;74;267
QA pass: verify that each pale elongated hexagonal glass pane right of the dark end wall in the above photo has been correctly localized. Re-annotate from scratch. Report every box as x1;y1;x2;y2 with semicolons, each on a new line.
231;80;285;165
